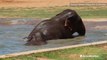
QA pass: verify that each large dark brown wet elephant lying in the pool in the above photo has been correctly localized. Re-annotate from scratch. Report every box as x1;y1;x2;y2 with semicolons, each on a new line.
26;9;85;45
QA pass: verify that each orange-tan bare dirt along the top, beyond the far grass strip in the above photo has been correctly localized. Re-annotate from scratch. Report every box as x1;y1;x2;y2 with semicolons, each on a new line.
0;0;107;8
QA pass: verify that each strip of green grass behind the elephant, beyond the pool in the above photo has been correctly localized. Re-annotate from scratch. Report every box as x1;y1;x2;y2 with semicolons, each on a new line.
0;6;107;18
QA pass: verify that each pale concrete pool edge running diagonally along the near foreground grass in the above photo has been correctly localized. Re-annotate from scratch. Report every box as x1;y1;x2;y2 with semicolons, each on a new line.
0;41;107;58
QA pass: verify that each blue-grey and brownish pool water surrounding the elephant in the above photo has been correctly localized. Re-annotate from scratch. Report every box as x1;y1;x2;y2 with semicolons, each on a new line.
0;18;107;55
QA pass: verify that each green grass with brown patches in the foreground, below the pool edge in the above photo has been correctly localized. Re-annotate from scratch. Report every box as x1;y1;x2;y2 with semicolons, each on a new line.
0;46;107;60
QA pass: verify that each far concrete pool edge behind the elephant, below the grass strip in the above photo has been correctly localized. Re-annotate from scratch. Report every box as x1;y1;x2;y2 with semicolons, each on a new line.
0;18;107;25
